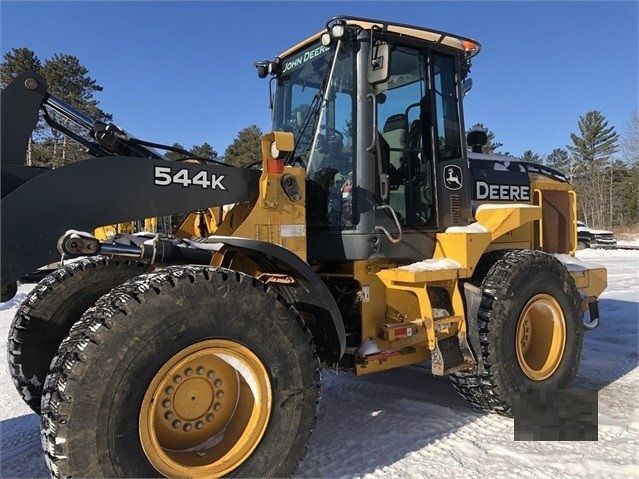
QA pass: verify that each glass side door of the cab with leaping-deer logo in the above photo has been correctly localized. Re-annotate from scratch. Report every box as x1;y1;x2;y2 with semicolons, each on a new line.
375;44;470;258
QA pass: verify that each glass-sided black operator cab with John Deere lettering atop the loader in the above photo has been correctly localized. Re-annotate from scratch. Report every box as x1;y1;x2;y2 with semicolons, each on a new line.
256;17;480;260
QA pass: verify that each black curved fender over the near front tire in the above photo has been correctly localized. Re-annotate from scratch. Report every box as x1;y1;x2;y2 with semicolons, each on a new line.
202;236;346;363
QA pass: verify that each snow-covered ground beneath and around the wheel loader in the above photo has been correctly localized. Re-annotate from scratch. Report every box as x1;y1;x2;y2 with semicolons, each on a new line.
0;250;639;479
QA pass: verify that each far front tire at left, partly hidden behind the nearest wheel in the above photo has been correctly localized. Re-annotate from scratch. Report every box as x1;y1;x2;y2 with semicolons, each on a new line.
7;256;147;414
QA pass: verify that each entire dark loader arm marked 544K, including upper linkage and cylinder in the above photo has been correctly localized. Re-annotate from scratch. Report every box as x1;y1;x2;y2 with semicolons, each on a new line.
0;71;260;291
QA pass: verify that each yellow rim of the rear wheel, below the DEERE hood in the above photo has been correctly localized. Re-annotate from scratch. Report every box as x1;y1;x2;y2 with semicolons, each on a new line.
515;294;566;381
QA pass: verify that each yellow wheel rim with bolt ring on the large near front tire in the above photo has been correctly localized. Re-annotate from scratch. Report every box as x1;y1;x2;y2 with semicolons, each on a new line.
139;339;273;477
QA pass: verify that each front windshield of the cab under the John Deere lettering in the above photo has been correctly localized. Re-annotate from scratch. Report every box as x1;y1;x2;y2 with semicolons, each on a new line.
273;39;355;229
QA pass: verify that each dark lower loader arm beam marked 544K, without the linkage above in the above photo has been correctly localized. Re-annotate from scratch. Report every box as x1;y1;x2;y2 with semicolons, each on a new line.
0;156;261;285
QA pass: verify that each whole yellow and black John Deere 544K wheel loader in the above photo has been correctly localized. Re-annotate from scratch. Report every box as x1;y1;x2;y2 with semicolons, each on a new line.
1;16;606;477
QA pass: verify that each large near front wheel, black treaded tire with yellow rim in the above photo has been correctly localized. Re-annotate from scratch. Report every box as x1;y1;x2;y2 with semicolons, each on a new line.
41;266;320;477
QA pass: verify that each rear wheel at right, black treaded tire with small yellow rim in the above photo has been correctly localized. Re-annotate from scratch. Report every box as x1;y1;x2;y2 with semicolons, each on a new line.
451;250;583;416
